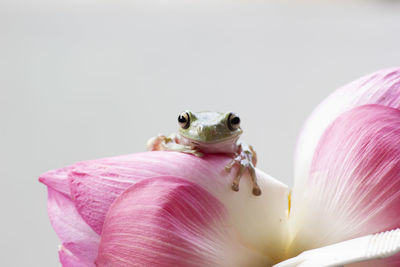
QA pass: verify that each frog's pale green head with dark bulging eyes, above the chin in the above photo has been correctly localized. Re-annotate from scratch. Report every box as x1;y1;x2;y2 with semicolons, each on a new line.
178;111;242;143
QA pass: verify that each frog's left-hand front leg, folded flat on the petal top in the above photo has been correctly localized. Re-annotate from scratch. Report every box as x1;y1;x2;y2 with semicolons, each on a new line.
147;134;203;157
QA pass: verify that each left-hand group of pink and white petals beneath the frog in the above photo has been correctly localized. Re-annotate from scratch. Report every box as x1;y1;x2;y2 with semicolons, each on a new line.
40;152;288;266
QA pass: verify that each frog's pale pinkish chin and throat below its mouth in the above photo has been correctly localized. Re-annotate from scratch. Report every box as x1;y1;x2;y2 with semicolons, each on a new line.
180;135;239;153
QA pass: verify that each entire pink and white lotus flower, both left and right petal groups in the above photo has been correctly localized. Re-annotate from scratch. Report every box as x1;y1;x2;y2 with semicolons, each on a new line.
40;69;400;267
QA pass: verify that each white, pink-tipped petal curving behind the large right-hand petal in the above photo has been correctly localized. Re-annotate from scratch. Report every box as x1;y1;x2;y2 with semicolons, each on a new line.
295;68;400;193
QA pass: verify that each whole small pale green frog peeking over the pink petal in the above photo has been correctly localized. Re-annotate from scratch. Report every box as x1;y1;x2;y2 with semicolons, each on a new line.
147;110;261;196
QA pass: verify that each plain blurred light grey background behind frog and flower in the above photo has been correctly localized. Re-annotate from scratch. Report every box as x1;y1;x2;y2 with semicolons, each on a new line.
0;0;400;267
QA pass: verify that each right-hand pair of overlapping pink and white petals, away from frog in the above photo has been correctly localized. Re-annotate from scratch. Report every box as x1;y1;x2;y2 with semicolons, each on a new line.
289;68;400;266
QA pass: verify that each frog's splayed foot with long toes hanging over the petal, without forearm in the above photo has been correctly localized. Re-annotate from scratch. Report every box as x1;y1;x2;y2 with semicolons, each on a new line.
225;153;261;196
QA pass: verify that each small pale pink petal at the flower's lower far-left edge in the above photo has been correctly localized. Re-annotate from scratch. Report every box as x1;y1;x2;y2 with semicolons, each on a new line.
48;188;100;267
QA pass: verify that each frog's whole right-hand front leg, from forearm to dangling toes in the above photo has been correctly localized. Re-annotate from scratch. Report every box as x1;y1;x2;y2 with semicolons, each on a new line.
225;143;261;196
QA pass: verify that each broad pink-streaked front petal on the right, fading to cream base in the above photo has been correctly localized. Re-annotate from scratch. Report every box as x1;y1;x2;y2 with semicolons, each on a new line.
292;105;400;266
